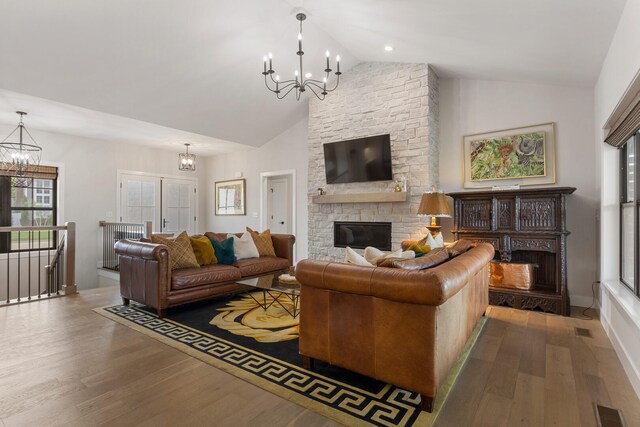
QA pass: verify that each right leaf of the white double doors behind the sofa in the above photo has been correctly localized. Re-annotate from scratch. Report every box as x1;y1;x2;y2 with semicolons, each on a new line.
161;178;196;235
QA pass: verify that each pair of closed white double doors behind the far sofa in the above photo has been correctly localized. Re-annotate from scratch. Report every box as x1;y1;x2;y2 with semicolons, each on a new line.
118;171;197;235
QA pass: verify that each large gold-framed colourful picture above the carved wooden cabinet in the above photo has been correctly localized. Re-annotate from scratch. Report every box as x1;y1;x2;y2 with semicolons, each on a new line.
462;122;556;188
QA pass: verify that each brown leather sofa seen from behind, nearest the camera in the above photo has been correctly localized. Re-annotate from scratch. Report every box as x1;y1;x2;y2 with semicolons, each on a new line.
296;243;495;412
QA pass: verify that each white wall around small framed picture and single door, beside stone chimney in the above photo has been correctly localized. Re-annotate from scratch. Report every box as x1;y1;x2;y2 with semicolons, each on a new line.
201;119;308;260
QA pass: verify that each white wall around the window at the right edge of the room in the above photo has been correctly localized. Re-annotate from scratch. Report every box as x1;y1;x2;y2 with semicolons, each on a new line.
594;0;640;396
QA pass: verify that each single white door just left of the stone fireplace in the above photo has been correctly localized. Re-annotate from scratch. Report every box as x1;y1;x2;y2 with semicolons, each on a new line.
260;169;296;235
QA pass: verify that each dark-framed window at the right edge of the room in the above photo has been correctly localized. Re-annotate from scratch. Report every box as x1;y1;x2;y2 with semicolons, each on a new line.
620;132;640;295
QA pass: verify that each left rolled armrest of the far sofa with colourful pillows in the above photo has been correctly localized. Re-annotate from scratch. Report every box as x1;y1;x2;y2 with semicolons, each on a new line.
114;239;171;309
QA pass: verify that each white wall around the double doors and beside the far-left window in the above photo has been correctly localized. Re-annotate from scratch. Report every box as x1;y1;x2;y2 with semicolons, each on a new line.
0;122;206;289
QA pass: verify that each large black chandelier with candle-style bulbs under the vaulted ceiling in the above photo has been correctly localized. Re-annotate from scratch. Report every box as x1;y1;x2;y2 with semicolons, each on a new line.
262;13;342;101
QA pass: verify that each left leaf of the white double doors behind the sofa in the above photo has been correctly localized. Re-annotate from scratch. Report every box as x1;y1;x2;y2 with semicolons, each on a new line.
120;174;160;230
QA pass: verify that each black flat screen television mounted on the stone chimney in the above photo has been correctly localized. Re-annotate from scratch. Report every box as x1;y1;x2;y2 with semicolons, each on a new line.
323;134;393;184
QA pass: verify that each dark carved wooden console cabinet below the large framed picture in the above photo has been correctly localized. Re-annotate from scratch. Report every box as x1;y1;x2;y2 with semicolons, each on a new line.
448;187;576;316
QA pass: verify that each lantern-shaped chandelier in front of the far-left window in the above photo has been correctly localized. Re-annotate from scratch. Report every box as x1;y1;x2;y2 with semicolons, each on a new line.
0;111;42;187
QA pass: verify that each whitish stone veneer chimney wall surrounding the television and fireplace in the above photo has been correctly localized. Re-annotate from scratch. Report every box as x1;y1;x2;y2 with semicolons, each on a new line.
308;63;439;260
